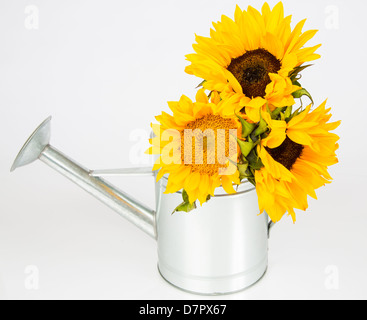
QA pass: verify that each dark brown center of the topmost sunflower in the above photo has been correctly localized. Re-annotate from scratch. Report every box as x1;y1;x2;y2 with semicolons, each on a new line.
227;49;281;98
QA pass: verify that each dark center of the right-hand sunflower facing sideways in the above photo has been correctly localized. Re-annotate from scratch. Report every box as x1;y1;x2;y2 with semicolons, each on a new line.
266;137;304;170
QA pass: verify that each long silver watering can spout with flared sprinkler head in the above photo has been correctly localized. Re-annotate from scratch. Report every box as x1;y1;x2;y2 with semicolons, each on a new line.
11;117;156;239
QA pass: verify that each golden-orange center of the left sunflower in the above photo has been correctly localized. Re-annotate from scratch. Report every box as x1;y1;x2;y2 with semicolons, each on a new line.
181;114;237;176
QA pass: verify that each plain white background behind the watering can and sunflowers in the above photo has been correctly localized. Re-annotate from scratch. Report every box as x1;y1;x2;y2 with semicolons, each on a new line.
0;0;367;299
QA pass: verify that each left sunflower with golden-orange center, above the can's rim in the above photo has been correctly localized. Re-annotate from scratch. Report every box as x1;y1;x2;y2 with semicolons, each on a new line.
147;89;241;204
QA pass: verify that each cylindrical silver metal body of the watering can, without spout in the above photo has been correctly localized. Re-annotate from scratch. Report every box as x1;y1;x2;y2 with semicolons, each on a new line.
157;179;268;295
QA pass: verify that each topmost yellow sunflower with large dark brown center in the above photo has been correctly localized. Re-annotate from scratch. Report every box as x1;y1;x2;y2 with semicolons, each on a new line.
185;2;321;122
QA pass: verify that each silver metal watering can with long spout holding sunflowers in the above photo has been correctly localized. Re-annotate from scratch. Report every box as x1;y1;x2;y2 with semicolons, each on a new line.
11;117;273;295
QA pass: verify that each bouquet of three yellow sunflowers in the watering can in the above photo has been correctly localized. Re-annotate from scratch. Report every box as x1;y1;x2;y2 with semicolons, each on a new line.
147;2;340;222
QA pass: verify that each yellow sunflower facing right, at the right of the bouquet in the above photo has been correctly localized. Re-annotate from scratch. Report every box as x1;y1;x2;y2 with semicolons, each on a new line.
255;101;340;222
